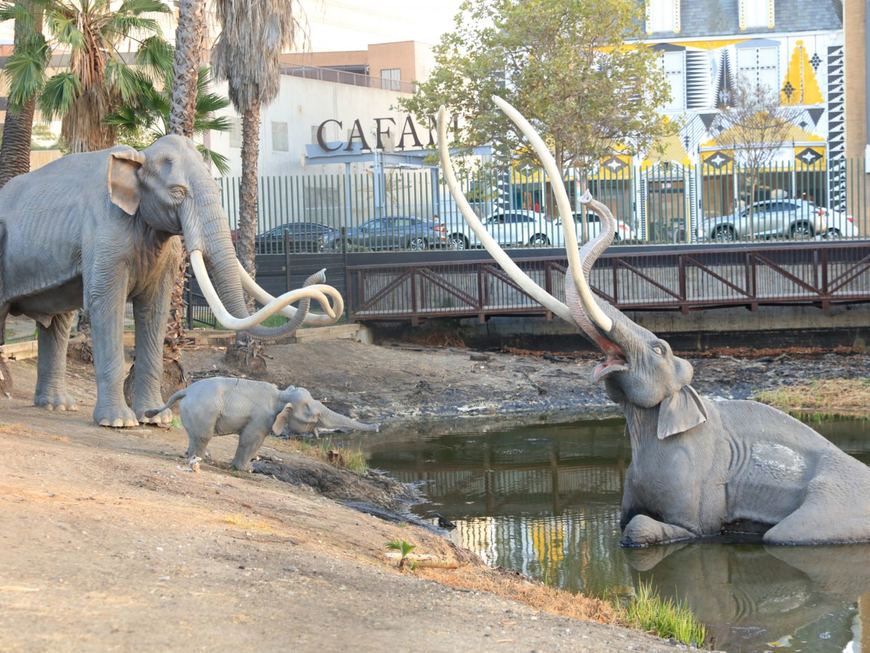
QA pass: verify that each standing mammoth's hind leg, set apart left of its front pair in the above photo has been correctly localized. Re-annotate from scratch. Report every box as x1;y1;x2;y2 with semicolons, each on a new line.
33;311;78;410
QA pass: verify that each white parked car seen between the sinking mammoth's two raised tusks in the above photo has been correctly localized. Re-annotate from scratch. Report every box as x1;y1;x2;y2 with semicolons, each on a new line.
445;209;561;249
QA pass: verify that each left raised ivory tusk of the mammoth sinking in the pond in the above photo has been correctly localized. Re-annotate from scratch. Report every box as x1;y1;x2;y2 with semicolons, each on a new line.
438;107;574;323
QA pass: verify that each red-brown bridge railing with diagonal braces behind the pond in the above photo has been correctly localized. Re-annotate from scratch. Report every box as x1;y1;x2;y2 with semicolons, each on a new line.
347;241;870;323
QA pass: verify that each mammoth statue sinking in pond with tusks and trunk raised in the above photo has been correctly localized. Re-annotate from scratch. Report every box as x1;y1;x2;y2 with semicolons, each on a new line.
438;98;870;546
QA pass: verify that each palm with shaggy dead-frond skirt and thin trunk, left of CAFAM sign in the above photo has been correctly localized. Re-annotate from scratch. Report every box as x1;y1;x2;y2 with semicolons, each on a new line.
211;0;298;284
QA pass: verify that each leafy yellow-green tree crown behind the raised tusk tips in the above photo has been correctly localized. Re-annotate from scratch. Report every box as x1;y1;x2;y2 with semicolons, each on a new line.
400;0;674;169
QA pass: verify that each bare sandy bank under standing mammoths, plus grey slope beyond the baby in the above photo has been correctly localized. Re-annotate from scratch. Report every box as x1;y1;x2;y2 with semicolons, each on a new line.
0;352;708;652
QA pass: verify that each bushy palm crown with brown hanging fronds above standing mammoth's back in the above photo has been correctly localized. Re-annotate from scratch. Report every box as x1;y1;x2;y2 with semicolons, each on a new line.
38;0;172;152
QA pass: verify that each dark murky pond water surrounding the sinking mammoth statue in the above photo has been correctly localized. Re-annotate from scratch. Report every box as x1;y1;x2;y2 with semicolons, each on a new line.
350;420;870;653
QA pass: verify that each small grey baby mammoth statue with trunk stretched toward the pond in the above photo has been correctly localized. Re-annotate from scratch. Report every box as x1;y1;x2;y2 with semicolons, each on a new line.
145;376;379;471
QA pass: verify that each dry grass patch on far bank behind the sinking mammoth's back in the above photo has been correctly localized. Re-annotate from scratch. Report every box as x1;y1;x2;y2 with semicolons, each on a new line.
755;378;870;420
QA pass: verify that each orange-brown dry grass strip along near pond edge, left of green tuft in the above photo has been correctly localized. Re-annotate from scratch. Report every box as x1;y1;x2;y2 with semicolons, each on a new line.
417;565;619;624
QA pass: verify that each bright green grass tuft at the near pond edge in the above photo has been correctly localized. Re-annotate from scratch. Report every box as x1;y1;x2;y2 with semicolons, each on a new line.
619;583;707;648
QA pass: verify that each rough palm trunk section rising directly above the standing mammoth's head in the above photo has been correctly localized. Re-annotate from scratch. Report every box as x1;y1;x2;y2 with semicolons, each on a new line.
169;0;205;138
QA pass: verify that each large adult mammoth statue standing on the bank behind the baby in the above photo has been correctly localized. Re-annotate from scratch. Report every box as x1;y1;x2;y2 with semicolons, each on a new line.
0;136;344;427
